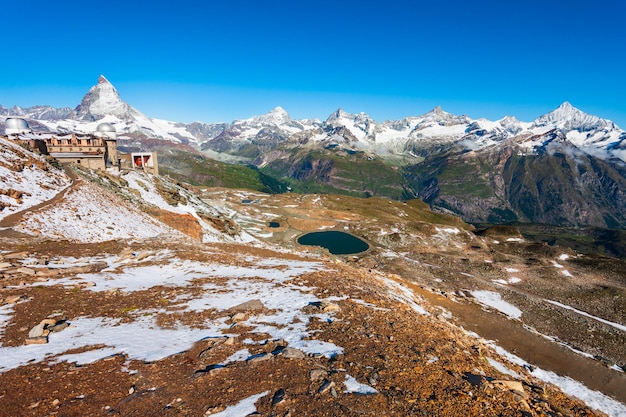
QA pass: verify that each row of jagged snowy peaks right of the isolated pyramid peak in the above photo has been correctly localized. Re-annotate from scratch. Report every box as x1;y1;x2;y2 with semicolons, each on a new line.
199;102;626;162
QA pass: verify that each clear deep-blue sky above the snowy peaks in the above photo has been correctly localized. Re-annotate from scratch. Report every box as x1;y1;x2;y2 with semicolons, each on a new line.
0;0;626;129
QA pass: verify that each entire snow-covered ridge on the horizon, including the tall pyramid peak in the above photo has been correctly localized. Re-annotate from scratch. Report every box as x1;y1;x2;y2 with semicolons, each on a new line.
0;76;626;162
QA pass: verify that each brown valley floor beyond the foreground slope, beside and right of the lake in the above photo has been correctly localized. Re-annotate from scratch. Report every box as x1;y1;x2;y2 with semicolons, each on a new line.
202;188;626;401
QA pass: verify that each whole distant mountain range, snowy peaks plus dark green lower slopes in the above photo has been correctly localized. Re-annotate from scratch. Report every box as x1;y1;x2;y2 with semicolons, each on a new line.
0;76;626;228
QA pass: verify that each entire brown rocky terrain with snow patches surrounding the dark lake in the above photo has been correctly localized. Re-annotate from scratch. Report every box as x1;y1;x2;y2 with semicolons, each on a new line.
0;141;626;417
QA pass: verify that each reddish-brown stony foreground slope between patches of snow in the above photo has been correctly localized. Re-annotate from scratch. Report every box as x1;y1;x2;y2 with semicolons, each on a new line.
0;239;601;416
